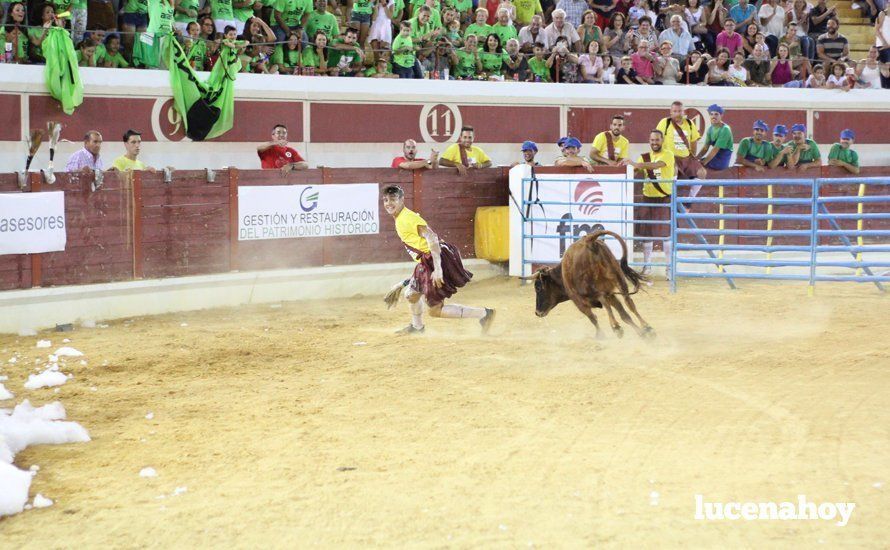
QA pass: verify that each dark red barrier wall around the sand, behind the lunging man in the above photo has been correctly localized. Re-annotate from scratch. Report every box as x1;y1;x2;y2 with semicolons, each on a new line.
0;168;507;290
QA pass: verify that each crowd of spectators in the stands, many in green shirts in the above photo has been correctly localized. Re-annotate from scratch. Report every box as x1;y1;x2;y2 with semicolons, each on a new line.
0;0;890;90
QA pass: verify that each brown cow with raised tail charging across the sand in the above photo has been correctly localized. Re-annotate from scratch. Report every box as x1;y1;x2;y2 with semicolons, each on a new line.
524;231;655;338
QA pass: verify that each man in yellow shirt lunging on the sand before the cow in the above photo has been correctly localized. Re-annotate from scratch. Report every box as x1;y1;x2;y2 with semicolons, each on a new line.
383;185;494;334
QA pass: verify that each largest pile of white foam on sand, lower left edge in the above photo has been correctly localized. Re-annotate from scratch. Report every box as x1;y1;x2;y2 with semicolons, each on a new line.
0;399;90;516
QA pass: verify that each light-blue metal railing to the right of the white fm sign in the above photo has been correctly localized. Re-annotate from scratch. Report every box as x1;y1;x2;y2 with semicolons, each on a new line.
670;177;890;292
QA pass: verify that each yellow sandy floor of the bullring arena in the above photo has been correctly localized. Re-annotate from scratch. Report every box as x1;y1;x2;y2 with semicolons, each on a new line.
0;280;890;549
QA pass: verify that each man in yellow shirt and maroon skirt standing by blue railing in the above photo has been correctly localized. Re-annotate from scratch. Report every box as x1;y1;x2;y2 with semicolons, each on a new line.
628;130;676;279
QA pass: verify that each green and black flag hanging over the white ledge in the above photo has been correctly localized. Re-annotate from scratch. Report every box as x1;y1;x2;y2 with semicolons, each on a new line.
167;40;241;141
